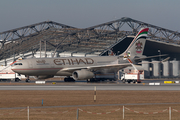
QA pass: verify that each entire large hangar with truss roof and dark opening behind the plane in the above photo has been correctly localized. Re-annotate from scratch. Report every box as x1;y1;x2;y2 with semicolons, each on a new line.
0;17;180;77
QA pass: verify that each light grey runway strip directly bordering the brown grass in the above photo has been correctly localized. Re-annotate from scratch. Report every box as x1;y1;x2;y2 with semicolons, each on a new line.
0;84;180;91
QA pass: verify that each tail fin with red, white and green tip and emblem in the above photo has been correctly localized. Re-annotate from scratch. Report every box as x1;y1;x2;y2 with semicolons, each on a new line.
123;28;149;58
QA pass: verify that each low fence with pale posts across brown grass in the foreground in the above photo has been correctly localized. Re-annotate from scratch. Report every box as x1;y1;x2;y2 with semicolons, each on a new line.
0;106;180;120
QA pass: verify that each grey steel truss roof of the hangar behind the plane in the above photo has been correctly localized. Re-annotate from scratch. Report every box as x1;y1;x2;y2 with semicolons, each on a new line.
0;17;180;60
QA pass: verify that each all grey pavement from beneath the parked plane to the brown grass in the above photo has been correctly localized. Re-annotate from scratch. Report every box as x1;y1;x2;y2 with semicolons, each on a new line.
0;80;180;90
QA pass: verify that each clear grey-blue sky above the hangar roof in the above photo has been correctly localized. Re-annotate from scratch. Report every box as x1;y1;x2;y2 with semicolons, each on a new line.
0;0;180;32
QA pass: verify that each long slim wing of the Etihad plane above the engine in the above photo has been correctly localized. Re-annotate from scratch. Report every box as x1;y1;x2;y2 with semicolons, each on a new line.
61;63;131;72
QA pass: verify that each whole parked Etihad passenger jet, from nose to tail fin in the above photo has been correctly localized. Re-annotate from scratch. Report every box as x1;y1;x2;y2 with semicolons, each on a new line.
12;28;149;82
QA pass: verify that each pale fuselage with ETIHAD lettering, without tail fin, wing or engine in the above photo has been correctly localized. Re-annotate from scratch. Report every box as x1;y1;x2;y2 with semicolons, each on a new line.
12;56;127;76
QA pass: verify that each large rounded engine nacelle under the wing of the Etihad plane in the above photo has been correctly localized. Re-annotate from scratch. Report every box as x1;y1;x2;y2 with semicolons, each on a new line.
72;69;94;80
